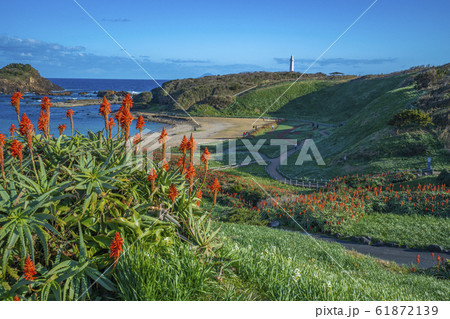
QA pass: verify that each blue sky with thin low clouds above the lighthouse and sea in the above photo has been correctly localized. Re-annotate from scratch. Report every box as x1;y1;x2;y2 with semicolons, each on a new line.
0;0;450;79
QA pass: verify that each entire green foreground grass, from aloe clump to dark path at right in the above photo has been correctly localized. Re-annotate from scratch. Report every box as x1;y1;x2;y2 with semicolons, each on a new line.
114;222;450;301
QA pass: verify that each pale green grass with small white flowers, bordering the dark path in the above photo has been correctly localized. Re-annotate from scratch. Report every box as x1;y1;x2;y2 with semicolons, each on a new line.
220;223;450;300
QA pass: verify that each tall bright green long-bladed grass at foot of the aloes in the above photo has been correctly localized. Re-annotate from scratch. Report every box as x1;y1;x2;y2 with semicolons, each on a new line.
114;242;253;301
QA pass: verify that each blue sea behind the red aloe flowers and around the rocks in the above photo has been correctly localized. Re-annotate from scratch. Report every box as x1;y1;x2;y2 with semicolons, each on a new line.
0;78;169;136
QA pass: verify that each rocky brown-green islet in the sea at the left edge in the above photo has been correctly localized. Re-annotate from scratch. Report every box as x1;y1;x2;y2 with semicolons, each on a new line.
0;63;64;94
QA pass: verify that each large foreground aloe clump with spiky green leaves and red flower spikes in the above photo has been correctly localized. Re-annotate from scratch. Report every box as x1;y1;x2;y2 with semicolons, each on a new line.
0;94;220;300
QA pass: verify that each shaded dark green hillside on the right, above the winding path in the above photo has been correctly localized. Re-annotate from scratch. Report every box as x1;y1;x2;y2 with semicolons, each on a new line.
241;65;450;178
